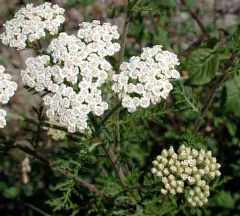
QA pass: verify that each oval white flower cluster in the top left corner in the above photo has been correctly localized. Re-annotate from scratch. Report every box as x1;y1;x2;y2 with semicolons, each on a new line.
0;2;65;50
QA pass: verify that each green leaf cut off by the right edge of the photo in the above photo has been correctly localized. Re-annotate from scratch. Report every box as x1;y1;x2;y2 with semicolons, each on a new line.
225;75;240;117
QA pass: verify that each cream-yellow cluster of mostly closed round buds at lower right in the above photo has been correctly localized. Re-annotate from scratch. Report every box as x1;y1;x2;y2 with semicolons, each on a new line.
152;145;221;207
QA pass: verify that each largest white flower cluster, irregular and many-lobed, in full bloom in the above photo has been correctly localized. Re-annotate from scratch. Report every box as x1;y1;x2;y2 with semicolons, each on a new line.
21;21;120;132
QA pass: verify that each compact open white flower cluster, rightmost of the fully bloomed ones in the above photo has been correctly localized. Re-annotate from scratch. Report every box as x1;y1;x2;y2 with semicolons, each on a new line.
113;45;180;112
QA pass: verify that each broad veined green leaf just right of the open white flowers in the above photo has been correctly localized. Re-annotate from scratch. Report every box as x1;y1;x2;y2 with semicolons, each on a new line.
187;48;219;85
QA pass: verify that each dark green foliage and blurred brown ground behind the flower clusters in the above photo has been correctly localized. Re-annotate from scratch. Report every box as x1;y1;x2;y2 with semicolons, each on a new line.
0;0;240;216
